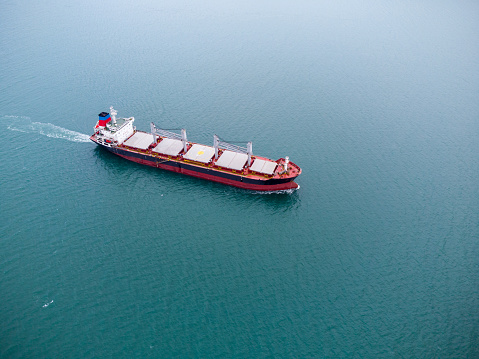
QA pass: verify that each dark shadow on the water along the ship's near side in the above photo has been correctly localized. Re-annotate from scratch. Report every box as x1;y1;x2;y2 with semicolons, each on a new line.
94;146;301;211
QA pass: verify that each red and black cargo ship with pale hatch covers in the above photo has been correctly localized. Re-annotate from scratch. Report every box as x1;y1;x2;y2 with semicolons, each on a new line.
90;107;301;191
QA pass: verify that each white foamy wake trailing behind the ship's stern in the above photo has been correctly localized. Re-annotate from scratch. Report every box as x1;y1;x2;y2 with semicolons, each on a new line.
2;116;90;142
